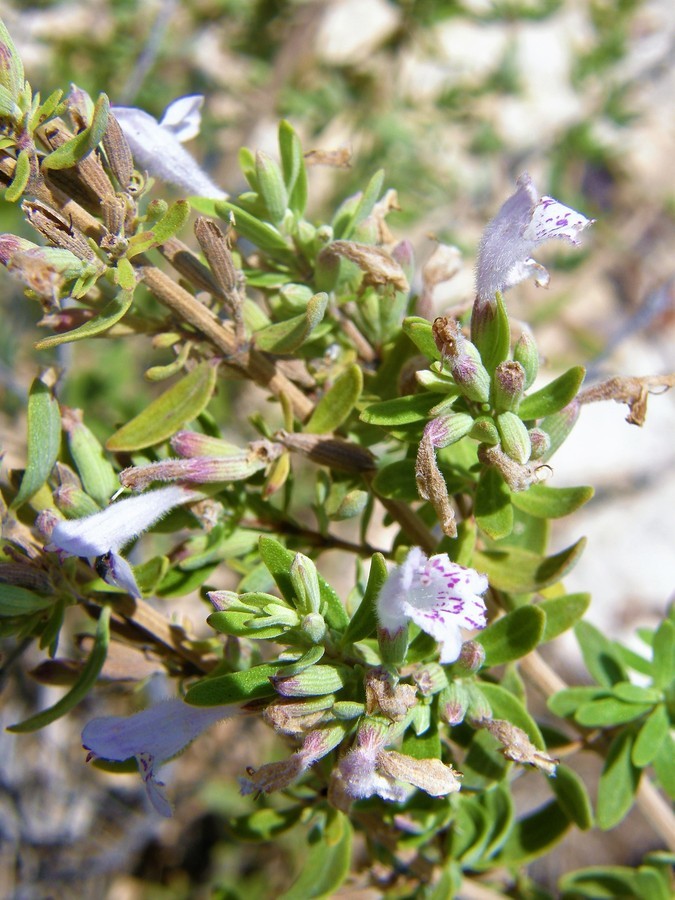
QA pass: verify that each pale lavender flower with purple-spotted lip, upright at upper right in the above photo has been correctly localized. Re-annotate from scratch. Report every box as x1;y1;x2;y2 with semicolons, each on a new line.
476;172;594;300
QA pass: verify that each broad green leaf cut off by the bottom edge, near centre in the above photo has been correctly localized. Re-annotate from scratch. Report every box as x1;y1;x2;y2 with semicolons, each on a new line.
279;813;352;900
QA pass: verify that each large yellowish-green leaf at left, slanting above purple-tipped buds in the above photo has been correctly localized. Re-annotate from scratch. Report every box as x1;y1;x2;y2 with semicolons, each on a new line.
106;362;216;451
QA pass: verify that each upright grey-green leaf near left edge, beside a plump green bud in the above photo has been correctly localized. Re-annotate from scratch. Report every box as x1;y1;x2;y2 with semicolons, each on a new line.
12;378;61;509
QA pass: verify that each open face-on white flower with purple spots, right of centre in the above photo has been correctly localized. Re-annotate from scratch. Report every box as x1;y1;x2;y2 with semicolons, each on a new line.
377;547;488;663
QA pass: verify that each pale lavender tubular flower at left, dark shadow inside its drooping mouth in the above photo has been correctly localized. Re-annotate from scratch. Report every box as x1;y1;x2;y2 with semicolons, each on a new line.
45;485;202;599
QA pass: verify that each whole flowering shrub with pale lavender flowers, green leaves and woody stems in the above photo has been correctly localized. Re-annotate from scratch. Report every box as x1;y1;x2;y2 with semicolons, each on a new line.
0;19;675;897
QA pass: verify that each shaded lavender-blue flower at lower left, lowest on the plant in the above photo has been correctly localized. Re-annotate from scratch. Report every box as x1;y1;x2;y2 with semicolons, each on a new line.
82;699;239;816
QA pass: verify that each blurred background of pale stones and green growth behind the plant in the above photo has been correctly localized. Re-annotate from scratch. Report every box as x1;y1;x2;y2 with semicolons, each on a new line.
0;0;675;900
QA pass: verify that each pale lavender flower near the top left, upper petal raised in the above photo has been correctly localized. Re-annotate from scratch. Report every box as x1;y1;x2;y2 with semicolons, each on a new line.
112;94;227;200
